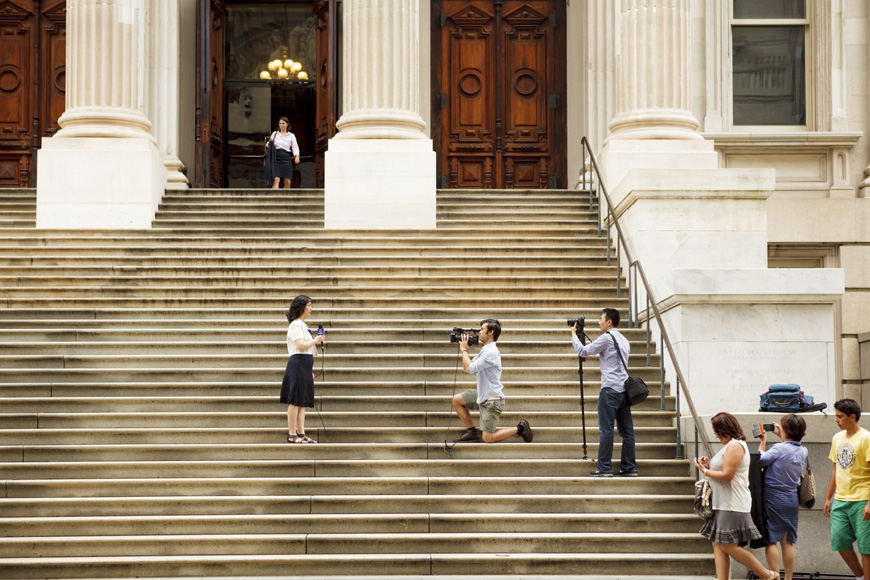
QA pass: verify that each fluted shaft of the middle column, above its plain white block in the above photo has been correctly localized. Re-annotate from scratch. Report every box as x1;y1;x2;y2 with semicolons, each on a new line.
336;0;426;139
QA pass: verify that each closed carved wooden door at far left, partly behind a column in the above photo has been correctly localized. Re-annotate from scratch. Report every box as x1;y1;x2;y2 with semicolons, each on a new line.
0;0;66;187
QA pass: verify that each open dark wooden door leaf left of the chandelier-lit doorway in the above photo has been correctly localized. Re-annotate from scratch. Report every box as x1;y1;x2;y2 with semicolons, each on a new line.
194;0;227;187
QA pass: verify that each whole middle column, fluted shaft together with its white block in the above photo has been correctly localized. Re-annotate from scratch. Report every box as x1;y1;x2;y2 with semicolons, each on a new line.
325;0;436;229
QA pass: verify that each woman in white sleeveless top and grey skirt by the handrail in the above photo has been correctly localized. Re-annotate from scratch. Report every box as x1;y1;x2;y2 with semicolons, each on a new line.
695;413;779;580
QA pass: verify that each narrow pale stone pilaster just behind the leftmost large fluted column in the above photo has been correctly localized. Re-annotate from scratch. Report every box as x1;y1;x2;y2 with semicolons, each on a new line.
145;0;189;190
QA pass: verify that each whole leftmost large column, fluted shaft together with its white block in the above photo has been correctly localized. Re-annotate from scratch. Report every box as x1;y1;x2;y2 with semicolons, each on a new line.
36;0;166;229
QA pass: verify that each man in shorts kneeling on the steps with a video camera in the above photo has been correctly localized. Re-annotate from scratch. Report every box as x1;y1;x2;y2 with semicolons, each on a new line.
453;318;532;443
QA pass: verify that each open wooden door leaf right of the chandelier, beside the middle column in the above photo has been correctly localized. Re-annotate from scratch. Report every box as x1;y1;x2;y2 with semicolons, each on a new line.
314;0;341;187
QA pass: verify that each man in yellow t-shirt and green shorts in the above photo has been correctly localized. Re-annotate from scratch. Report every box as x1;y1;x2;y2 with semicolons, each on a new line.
823;399;870;580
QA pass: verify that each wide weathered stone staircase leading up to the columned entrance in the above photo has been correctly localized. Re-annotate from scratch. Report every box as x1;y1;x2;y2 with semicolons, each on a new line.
0;190;713;578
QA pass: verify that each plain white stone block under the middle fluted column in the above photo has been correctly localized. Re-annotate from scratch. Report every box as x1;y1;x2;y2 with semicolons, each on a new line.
324;138;436;230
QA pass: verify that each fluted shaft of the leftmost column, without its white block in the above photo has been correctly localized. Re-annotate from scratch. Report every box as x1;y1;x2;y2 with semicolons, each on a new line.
57;0;153;140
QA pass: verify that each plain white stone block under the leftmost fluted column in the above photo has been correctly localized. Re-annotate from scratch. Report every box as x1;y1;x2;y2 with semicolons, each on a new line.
36;137;166;229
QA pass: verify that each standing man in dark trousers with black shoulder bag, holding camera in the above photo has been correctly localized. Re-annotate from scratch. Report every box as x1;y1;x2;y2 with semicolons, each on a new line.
571;308;637;477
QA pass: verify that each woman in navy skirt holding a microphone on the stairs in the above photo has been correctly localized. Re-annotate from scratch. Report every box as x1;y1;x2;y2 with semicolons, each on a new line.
281;294;326;443
